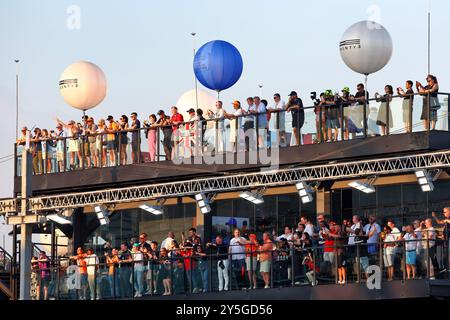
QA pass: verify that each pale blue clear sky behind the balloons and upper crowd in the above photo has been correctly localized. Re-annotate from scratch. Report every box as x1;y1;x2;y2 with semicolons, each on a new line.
0;0;450;245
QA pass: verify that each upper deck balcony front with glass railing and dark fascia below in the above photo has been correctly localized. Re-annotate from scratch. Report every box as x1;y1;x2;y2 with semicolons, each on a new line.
14;93;450;195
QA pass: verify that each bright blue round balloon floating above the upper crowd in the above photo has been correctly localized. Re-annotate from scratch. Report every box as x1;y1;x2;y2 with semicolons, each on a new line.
194;40;243;91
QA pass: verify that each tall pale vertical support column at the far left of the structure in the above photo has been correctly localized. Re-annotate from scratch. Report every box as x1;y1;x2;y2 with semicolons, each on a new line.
19;148;33;300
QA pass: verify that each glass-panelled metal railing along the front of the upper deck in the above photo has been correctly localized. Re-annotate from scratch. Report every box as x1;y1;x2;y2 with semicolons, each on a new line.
14;93;450;175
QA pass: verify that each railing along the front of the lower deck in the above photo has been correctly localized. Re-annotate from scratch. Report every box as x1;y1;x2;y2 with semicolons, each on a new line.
28;231;450;300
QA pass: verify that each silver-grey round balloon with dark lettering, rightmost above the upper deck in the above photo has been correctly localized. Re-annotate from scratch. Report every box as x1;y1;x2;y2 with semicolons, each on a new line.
339;21;393;75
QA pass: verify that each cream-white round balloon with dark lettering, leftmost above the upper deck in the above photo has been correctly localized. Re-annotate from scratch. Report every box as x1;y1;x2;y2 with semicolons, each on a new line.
59;61;106;111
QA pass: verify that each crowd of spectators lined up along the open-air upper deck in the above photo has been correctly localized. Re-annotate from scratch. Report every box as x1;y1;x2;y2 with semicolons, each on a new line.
17;75;440;174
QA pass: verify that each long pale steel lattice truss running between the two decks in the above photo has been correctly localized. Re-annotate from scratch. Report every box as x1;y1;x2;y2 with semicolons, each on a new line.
0;151;450;213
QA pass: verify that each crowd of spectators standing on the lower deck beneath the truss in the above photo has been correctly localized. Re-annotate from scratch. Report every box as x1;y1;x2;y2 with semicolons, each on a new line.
32;207;450;299
